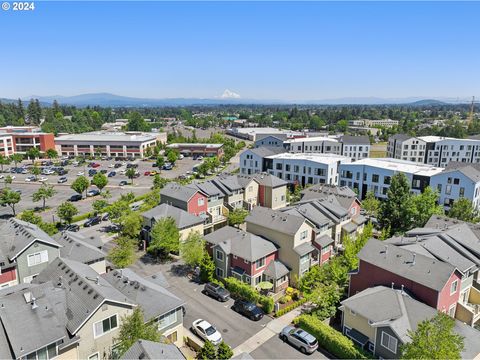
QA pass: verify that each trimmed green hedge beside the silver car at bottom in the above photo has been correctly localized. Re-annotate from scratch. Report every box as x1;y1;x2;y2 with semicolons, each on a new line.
295;315;371;359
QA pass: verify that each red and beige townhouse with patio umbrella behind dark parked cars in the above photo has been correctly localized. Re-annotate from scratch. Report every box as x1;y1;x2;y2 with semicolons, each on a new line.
205;226;289;292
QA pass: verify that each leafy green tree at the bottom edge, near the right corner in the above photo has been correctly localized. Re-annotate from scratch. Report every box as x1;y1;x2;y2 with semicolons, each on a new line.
400;312;465;359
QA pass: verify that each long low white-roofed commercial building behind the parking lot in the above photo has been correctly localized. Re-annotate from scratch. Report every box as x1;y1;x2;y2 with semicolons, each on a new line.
55;131;167;158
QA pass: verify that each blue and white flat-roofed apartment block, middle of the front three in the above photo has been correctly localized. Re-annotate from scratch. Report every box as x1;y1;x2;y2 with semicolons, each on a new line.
264;153;351;186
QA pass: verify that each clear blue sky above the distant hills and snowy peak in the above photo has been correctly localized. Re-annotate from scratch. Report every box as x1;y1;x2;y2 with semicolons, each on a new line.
0;1;480;100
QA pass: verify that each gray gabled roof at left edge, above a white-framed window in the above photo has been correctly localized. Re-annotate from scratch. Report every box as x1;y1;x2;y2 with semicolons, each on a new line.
0;218;60;261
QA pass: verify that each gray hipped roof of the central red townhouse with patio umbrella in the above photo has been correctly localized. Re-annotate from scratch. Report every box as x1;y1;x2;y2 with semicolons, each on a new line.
205;226;277;261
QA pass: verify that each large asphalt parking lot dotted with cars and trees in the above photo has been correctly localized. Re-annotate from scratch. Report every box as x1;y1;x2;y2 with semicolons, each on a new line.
0;157;200;221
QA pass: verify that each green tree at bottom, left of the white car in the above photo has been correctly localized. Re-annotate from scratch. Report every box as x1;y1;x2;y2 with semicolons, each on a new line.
115;307;161;357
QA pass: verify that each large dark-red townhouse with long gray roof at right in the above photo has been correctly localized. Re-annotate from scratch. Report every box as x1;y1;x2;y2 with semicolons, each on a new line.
349;239;461;317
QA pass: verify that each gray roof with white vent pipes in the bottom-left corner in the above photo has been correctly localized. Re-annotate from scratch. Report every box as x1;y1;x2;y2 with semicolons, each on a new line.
0;283;68;358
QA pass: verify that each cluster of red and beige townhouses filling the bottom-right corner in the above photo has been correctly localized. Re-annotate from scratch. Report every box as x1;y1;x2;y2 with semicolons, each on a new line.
340;215;480;359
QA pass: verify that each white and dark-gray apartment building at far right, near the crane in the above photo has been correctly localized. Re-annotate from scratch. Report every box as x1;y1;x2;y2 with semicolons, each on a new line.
387;134;480;167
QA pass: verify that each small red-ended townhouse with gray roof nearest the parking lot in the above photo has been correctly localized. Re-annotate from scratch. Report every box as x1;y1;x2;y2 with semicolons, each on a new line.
160;183;208;217
